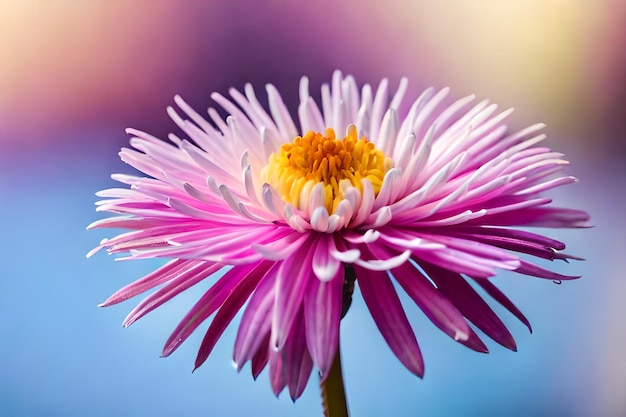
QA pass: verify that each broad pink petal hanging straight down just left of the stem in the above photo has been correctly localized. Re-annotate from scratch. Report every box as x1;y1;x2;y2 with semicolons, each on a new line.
304;267;344;379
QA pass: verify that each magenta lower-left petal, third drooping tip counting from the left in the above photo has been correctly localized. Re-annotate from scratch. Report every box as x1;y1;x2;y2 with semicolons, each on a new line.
161;264;256;356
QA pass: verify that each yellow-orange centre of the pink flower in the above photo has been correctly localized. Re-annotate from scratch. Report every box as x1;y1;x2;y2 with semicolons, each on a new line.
261;125;392;214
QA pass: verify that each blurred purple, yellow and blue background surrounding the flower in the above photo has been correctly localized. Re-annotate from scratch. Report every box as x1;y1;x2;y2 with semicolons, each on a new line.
0;0;626;416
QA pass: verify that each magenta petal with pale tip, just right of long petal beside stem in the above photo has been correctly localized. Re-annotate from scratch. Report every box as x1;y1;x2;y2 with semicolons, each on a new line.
392;262;470;341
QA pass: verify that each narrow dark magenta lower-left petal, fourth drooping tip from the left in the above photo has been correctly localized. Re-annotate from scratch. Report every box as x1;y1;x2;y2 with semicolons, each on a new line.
195;261;271;369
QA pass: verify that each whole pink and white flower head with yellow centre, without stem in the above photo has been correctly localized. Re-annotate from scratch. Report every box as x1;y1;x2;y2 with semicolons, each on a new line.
89;71;588;399
